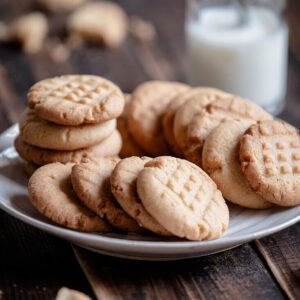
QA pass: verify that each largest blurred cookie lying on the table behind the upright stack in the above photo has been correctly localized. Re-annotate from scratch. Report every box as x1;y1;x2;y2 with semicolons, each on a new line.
67;1;128;47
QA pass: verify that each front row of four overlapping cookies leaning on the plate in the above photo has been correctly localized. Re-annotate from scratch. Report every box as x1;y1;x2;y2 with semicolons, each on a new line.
28;156;229;240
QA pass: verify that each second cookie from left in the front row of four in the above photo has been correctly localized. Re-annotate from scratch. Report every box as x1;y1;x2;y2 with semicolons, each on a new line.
71;158;141;232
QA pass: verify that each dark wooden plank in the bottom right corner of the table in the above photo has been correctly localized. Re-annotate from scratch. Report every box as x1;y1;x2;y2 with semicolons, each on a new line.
256;223;300;300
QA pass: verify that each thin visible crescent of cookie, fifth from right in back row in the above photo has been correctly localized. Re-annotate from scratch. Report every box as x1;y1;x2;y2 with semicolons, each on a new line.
162;87;229;157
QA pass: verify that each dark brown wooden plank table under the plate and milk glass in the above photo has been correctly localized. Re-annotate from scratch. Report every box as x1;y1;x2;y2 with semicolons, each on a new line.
0;0;300;300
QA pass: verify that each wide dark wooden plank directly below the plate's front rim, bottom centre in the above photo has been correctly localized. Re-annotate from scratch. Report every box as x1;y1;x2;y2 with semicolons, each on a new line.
74;245;284;300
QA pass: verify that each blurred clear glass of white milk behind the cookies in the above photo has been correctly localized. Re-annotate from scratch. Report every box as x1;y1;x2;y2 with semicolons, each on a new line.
185;0;288;114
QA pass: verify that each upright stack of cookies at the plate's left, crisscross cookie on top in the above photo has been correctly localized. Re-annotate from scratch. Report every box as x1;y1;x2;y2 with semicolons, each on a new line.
15;75;124;172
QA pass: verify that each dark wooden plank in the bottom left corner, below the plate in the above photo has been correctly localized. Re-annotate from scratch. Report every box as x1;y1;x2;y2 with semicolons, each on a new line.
0;210;93;300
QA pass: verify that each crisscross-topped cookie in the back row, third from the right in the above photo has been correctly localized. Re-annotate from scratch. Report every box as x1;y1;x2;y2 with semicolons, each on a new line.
184;96;272;166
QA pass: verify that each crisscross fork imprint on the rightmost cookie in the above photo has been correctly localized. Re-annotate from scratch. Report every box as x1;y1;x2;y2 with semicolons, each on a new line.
261;136;300;177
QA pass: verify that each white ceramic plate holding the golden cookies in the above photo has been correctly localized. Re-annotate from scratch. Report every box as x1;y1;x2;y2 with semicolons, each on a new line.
0;126;300;260
